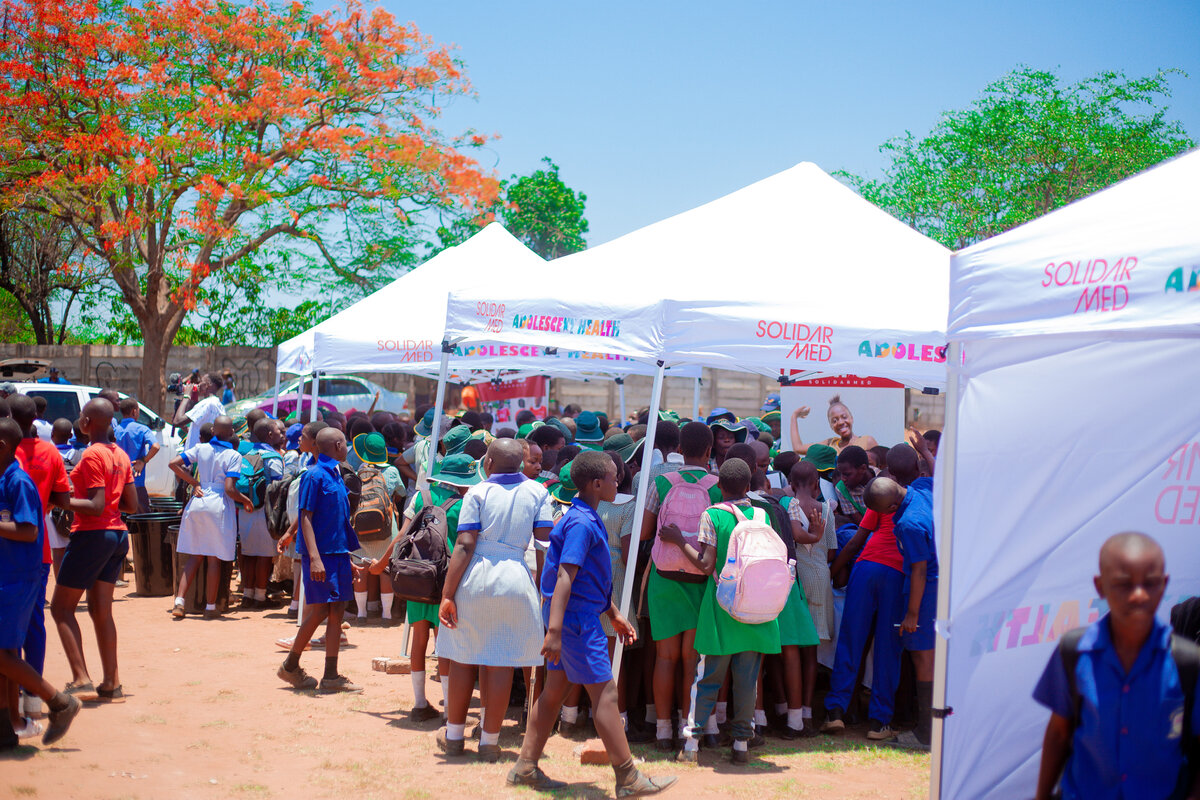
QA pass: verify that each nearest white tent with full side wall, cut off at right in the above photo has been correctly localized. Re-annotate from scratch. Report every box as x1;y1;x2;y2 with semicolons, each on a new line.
932;151;1200;798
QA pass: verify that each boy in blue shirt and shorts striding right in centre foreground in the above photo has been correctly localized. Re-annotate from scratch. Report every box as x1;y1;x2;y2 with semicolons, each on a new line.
508;451;676;798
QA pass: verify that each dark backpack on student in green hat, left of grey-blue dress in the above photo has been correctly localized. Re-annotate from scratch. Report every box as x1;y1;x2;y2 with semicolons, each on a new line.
388;489;453;604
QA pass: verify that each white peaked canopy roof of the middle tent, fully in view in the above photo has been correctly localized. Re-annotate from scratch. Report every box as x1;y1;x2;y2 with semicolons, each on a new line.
446;163;949;386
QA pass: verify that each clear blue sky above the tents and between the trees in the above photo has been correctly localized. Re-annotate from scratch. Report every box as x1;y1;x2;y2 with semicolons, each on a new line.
388;0;1200;245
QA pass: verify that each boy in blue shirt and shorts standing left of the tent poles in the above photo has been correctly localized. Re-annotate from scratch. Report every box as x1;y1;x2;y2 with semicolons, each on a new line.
275;428;362;693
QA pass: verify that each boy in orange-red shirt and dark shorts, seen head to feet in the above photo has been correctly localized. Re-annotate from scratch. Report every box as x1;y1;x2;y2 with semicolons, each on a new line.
50;398;138;702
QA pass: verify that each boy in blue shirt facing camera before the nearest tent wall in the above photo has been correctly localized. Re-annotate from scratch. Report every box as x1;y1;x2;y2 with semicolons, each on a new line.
1033;533;1200;800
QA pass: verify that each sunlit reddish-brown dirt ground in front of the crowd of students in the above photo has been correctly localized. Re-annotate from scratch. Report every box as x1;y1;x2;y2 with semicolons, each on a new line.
0;576;929;800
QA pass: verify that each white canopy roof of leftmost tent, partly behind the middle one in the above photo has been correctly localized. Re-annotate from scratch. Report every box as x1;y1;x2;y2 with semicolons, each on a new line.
278;223;695;381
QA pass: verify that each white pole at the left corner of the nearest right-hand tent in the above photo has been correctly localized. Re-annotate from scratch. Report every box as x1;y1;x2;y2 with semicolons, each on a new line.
929;342;962;800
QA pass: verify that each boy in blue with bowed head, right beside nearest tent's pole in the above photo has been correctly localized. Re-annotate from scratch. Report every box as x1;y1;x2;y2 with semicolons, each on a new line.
863;477;937;751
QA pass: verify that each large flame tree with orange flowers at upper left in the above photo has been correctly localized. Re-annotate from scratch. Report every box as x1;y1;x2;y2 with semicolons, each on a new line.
0;0;498;404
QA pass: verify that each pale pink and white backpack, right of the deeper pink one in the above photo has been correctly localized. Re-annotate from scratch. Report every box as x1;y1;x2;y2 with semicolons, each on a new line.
716;503;796;625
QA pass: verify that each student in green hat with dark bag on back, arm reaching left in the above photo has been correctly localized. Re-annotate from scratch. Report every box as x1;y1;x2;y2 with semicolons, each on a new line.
370;453;480;722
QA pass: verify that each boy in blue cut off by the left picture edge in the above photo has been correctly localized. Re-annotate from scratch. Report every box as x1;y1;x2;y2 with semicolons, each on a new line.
0;417;83;752
